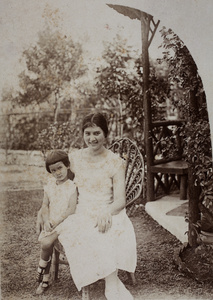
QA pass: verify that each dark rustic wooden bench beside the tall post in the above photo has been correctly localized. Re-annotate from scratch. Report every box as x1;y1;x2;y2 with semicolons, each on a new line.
148;120;188;201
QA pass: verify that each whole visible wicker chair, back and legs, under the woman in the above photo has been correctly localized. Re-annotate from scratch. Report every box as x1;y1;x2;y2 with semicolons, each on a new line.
51;138;144;285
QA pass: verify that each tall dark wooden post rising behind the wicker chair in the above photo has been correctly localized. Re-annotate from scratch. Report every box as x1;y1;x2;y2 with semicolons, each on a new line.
141;12;154;201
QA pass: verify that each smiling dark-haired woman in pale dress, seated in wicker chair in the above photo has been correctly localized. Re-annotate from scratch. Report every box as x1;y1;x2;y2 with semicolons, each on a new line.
37;113;136;300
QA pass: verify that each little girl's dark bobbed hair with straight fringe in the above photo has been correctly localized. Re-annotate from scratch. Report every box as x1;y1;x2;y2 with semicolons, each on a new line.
45;149;74;180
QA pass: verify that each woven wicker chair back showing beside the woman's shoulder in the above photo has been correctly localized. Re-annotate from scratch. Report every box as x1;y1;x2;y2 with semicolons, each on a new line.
109;138;144;207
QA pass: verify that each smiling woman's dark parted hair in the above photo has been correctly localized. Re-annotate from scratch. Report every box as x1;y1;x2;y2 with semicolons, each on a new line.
82;113;109;137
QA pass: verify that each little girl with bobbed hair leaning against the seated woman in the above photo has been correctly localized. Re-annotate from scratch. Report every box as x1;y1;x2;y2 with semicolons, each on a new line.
36;150;77;294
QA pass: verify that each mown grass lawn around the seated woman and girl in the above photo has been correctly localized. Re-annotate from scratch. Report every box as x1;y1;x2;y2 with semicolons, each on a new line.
0;190;213;300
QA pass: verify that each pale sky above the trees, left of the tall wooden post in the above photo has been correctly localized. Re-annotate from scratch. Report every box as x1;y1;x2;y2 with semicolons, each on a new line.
0;0;163;92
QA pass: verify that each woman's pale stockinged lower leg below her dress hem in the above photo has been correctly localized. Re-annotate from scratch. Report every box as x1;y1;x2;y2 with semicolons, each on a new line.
105;271;133;300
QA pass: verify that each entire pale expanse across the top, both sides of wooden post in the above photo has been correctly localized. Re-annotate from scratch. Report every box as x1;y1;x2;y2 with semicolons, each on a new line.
0;0;213;93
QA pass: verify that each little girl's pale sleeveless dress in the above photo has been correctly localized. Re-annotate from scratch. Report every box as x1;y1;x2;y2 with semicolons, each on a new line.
38;177;76;241
